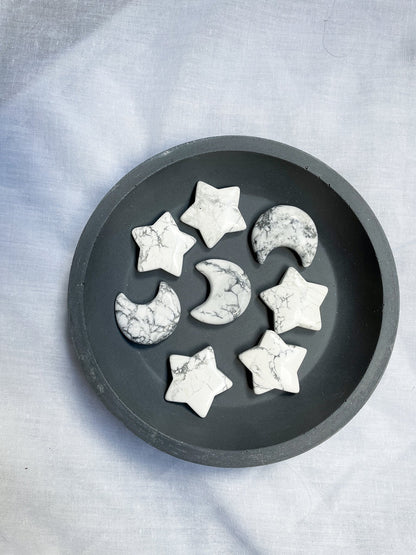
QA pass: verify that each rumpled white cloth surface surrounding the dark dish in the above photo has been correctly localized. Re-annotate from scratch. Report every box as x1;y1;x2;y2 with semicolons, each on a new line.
0;0;416;555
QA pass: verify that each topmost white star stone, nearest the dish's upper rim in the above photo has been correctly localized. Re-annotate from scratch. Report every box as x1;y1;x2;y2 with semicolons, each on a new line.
181;181;247;248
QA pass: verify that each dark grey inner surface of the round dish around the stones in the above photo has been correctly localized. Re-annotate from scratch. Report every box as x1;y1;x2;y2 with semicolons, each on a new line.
84;152;383;450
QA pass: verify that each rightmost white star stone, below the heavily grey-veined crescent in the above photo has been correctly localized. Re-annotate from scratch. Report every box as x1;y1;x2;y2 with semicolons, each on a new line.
260;268;328;333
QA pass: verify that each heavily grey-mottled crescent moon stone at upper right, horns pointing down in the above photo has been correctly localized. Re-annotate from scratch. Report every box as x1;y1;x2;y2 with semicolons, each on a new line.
251;205;318;268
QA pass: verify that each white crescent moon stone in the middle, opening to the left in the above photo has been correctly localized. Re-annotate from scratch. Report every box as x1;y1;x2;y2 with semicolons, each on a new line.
191;258;251;326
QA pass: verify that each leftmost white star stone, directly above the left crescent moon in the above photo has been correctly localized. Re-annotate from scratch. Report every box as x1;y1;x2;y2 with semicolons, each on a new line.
131;212;196;276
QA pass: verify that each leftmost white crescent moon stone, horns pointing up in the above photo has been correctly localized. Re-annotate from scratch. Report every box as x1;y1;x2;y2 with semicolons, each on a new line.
114;281;181;345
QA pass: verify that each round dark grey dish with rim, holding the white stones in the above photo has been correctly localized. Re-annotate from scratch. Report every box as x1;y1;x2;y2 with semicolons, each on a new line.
68;136;399;467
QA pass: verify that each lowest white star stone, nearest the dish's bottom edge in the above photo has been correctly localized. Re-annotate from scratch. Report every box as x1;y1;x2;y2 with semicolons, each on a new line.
165;346;233;418
